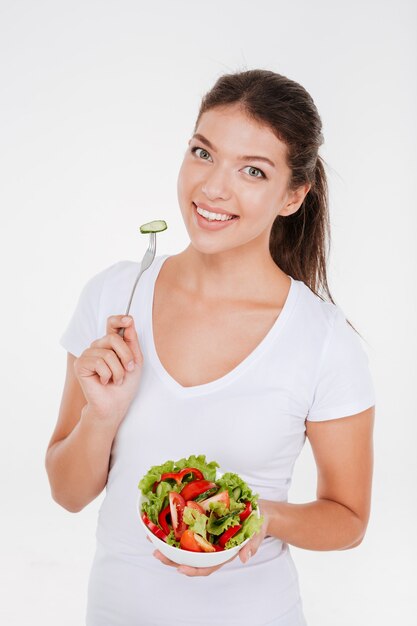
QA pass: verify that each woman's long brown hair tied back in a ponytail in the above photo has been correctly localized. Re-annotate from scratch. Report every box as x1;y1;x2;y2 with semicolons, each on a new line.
195;69;334;302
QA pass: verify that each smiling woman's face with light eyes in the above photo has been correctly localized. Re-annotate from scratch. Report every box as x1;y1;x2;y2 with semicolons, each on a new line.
178;105;306;253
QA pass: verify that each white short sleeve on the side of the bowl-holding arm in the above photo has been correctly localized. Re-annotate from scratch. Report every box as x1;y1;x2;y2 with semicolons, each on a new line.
307;309;375;422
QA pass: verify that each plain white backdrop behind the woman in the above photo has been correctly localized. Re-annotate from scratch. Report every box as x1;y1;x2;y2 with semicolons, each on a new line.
0;0;417;626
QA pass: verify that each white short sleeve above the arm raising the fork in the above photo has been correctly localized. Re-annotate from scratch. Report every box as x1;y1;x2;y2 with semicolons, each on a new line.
59;268;108;357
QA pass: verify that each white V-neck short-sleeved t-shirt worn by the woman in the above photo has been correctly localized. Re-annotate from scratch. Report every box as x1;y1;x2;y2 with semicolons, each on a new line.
60;255;375;626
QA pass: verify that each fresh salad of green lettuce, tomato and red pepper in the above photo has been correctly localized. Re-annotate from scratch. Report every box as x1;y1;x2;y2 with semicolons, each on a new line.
139;455;263;552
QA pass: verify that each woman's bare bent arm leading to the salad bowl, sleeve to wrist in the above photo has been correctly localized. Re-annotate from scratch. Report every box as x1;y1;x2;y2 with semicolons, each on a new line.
252;407;375;556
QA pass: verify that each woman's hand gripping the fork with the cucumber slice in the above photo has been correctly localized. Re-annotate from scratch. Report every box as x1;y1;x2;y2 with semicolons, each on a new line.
74;315;143;424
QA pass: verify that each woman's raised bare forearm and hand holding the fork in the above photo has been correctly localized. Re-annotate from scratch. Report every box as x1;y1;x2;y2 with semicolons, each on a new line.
45;315;142;512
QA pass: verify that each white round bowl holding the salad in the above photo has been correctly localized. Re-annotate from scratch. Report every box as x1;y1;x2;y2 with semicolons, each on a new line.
137;472;261;567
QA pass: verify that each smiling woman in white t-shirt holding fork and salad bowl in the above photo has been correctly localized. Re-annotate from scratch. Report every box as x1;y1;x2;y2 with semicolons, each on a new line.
46;70;374;626
